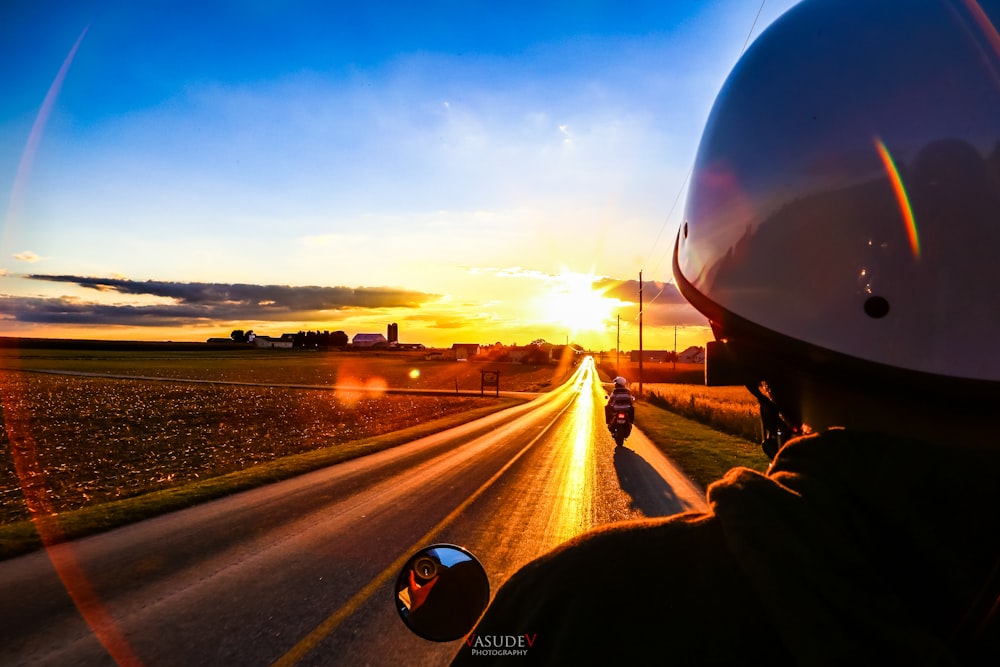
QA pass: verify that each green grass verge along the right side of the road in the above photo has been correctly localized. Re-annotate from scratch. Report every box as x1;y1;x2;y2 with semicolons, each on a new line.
635;402;769;489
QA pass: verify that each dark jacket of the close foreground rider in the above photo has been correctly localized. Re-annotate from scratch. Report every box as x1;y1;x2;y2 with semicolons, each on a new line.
455;431;1000;667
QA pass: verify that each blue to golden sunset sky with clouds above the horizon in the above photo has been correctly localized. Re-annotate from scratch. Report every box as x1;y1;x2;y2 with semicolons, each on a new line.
0;0;794;349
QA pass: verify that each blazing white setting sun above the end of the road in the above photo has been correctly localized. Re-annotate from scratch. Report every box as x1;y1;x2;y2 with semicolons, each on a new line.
539;271;622;333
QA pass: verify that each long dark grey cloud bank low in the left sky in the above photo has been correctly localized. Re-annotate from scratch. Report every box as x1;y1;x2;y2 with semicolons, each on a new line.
0;274;438;327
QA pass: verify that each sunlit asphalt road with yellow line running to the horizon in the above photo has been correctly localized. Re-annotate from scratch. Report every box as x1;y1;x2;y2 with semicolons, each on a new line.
0;360;704;666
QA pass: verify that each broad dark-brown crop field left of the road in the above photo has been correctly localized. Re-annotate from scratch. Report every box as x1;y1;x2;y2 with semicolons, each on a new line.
0;350;571;524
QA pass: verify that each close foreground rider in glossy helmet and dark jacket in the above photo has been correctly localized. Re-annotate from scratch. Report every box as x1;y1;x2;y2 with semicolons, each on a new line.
456;0;1000;666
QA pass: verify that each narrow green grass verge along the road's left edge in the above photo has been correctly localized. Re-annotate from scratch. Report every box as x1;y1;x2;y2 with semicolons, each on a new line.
0;398;522;560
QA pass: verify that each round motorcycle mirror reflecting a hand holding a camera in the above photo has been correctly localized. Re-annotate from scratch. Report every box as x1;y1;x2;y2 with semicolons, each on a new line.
394;544;490;642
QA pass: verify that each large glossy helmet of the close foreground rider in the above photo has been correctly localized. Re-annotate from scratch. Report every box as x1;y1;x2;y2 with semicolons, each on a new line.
673;0;1000;392
